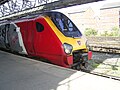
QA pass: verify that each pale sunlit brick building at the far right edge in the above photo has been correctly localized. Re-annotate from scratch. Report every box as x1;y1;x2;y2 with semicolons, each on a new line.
98;2;120;31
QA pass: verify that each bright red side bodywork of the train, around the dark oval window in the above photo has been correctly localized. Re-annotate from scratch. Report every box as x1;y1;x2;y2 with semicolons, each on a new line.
17;17;70;67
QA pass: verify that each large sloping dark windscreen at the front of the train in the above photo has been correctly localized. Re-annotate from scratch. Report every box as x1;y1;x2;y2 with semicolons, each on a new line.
47;12;82;37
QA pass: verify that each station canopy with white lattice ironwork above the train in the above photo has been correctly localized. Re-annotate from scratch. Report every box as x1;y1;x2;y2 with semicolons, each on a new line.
0;0;103;20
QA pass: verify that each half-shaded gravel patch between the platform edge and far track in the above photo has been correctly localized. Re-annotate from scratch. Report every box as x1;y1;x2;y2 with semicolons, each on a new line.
89;52;120;77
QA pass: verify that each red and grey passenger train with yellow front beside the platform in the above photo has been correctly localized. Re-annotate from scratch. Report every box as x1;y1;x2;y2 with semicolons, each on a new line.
0;11;92;69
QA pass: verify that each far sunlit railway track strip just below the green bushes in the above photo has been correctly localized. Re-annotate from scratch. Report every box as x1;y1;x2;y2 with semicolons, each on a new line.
87;37;120;53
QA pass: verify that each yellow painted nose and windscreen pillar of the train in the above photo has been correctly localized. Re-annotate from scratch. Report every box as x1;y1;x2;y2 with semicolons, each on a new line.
45;17;88;55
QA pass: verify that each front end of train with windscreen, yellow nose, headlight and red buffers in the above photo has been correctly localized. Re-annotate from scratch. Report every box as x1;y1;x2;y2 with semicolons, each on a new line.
45;12;92;69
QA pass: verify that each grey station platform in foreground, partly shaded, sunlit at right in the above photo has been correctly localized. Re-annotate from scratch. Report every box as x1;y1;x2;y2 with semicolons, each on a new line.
0;51;120;90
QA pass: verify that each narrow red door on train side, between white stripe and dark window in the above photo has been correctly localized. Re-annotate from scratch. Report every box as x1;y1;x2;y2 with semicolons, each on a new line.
26;21;35;55
